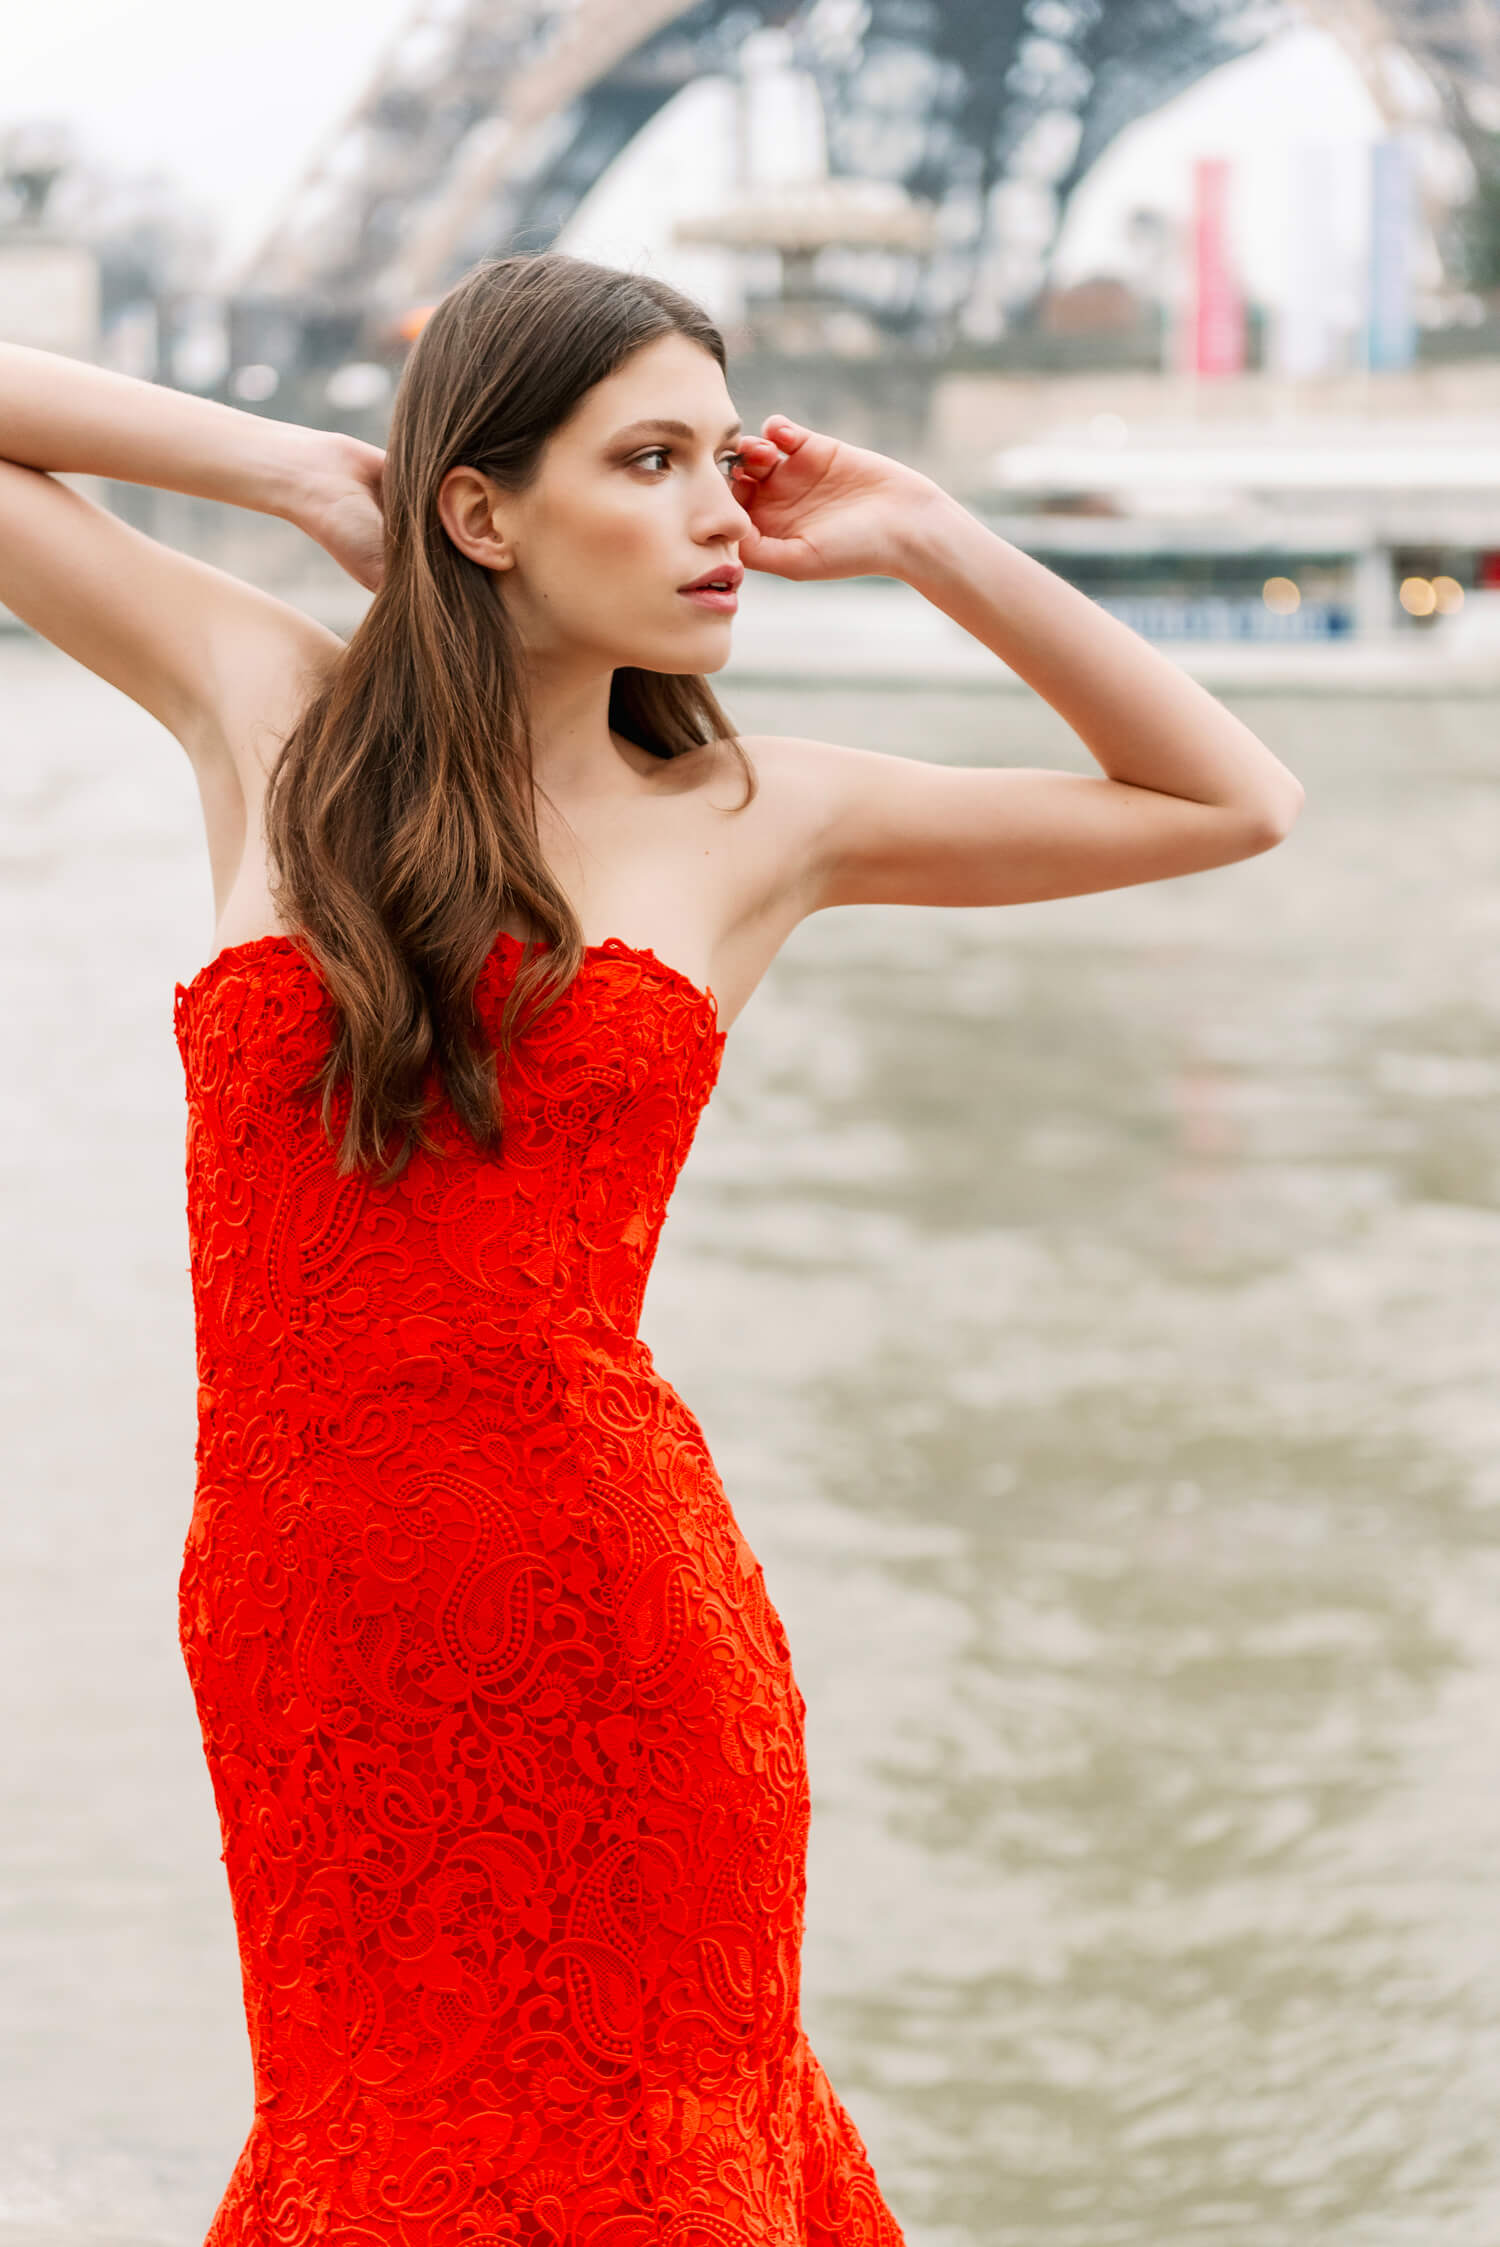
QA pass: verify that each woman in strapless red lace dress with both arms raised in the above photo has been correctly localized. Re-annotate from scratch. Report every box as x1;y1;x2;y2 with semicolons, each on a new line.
0;256;1302;2247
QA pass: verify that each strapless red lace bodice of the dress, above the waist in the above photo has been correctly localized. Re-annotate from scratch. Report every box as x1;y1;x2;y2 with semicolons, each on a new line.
175;935;723;1382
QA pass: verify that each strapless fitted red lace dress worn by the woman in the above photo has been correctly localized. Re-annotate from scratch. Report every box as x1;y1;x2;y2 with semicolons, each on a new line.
175;937;900;2247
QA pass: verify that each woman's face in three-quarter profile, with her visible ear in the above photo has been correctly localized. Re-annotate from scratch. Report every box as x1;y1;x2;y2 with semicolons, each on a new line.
440;335;750;672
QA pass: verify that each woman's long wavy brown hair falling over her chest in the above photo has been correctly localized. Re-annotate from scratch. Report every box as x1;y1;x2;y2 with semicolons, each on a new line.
265;254;754;1180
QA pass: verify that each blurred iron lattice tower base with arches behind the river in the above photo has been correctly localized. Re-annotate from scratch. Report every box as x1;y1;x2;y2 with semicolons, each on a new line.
238;0;1500;342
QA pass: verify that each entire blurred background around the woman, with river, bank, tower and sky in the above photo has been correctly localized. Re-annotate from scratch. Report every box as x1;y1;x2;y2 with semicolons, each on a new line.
0;0;1500;2247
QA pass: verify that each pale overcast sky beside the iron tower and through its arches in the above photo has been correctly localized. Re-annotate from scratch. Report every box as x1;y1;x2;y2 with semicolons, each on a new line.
0;0;1410;301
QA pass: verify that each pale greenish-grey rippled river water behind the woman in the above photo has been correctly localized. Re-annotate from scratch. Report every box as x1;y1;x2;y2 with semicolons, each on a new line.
0;640;1500;2247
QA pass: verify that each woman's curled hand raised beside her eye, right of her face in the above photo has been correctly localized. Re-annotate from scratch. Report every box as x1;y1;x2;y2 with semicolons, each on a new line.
734;413;941;577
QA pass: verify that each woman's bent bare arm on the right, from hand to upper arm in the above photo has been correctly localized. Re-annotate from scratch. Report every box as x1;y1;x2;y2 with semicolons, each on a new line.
739;416;1302;910
